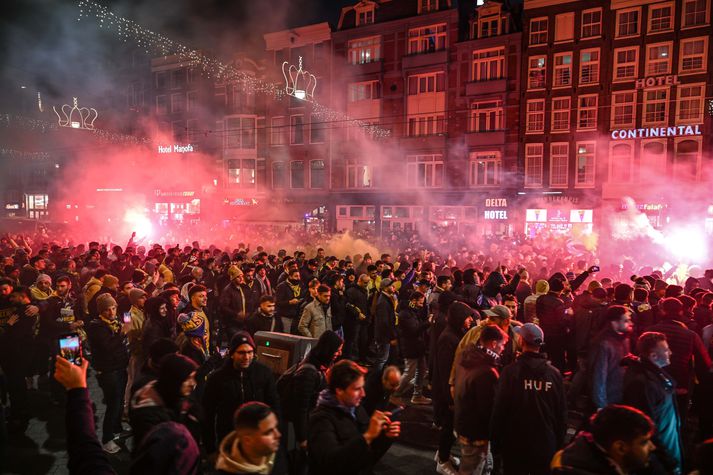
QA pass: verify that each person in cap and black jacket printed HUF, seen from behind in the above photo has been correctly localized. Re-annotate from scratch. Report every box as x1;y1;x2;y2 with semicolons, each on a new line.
491;323;567;475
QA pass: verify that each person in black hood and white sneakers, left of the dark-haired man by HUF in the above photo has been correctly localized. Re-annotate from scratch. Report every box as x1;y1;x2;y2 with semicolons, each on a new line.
431;301;475;475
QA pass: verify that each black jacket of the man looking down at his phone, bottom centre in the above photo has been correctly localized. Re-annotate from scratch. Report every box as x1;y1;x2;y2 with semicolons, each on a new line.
307;398;391;475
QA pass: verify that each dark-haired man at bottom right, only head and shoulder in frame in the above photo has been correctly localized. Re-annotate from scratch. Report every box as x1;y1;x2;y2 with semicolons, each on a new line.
551;405;655;475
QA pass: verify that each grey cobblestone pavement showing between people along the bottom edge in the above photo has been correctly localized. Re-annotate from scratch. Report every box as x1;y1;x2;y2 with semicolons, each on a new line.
0;375;435;475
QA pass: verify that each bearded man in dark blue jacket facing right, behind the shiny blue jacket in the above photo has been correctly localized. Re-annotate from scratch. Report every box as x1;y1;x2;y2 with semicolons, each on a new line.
591;305;634;409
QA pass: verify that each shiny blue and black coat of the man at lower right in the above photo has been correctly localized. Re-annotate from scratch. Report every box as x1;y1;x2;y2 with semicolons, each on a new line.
622;356;682;470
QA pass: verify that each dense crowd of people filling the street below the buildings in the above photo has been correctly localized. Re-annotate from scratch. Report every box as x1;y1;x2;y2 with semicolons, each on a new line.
0;228;713;475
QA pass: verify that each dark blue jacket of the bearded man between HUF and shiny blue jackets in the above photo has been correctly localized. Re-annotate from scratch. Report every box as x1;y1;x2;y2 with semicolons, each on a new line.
589;325;629;408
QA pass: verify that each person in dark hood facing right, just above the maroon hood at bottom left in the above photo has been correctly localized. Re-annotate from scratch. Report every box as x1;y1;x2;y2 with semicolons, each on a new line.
129;354;199;456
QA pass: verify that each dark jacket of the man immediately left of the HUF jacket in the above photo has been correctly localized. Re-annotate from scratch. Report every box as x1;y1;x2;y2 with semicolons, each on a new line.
453;345;499;440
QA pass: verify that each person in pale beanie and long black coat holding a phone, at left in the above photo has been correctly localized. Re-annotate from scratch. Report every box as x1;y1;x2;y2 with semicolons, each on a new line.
87;294;129;454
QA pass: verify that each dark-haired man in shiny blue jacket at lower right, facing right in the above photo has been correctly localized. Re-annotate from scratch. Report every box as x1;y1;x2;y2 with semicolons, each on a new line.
622;332;683;473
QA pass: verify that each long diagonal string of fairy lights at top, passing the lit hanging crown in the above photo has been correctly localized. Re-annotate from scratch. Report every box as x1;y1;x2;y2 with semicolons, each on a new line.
77;0;391;139
